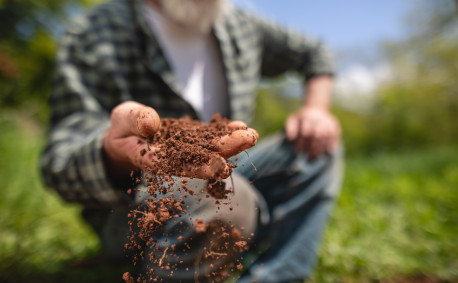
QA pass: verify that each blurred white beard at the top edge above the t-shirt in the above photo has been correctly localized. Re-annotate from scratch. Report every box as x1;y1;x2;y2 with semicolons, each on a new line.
160;0;229;33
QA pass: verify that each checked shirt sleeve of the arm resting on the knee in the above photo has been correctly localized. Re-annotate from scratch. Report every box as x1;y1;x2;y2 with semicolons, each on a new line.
252;11;334;79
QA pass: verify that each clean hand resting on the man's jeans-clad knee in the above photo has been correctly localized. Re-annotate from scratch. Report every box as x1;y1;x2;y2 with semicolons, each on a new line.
285;106;340;160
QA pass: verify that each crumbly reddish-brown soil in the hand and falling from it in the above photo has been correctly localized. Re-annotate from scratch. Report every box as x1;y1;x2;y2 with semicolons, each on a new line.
122;115;247;283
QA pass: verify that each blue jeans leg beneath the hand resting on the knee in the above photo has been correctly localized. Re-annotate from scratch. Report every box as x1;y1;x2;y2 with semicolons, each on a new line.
235;134;343;283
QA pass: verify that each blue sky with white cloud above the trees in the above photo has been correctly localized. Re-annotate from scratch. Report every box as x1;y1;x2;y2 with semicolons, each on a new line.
233;0;414;96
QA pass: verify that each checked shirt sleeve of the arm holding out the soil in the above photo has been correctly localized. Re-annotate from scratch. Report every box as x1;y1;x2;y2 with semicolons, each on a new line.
40;20;128;206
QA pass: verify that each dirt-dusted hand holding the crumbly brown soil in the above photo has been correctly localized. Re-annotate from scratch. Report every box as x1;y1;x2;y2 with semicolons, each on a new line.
103;102;259;180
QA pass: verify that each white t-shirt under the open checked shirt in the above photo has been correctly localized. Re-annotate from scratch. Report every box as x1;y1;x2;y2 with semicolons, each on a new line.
144;3;229;122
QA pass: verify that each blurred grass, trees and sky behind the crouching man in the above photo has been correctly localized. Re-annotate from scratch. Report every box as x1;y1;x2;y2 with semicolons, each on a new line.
0;0;458;282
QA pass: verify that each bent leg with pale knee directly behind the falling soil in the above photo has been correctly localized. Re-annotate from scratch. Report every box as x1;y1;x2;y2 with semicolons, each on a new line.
137;174;259;282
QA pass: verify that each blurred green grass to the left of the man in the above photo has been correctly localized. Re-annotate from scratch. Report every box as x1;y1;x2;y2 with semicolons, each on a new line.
0;112;98;282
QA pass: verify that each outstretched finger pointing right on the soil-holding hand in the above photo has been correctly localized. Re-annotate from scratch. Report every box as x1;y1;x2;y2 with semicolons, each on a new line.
214;128;259;159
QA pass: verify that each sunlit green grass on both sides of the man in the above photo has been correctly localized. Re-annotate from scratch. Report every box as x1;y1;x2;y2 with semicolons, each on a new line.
0;117;458;282
